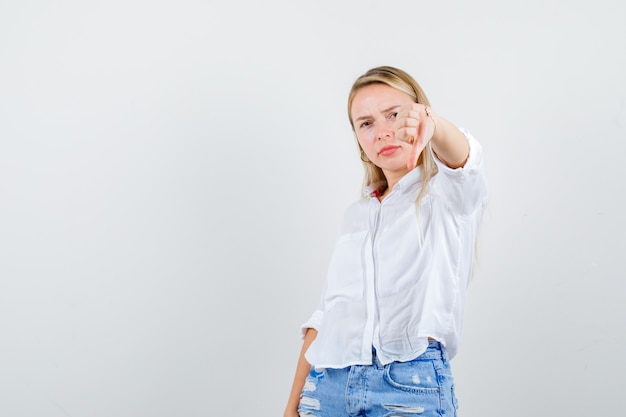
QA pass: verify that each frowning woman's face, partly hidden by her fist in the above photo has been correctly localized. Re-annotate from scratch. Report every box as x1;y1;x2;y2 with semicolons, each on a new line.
350;84;414;178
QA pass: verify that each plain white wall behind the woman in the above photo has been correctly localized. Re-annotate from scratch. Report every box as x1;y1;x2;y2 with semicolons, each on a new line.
0;0;626;417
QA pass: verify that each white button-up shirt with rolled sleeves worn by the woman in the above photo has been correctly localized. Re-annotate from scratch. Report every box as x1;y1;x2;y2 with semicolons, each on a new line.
302;130;487;368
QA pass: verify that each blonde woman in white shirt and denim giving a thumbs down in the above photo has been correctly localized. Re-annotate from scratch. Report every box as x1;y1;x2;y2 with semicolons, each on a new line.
284;67;487;417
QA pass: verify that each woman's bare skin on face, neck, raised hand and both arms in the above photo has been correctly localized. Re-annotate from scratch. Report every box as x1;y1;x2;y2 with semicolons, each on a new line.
283;84;469;417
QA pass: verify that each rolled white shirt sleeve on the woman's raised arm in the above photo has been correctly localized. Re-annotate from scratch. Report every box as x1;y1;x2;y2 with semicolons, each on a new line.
431;129;488;214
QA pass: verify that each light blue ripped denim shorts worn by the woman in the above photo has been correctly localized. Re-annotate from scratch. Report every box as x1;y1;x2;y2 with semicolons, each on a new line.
298;340;458;417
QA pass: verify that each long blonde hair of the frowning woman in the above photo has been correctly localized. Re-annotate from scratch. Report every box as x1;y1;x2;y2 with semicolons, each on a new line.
348;66;437;203
